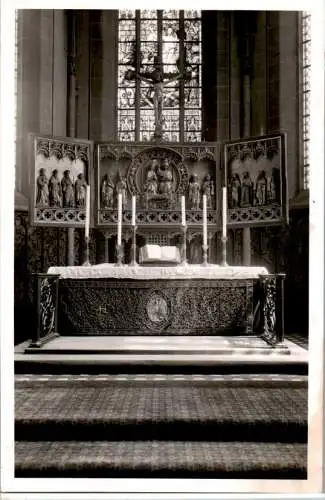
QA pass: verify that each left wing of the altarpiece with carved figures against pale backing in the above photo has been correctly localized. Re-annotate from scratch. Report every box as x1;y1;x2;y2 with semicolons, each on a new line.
31;136;93;227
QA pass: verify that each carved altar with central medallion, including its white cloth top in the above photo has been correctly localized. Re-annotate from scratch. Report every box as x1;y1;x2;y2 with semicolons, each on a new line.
27;264;284;346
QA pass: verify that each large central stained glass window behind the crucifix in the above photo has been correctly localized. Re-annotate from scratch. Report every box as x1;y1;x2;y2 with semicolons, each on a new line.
117;10;202;142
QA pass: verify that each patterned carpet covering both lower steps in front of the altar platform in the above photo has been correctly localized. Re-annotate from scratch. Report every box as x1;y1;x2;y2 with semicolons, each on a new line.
15;374;307;479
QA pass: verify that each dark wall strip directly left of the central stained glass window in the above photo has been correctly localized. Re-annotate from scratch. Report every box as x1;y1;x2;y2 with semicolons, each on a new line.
76;10;117;141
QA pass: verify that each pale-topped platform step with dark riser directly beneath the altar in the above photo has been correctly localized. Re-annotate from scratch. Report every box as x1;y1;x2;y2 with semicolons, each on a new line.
15;336;308;374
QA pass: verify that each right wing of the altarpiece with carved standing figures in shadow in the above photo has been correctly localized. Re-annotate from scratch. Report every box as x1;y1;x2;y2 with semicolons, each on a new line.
225;134;288;226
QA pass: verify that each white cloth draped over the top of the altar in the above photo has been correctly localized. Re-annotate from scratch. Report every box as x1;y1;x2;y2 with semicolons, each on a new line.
48;264;268;280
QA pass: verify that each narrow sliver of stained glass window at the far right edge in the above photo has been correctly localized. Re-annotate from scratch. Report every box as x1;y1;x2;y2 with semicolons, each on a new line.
301;13;311;189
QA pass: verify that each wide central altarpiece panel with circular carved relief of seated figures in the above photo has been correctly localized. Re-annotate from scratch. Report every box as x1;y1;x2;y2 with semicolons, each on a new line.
96;144;218;227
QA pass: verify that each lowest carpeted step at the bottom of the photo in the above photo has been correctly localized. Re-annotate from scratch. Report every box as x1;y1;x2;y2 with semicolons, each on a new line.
15;441;307;480
